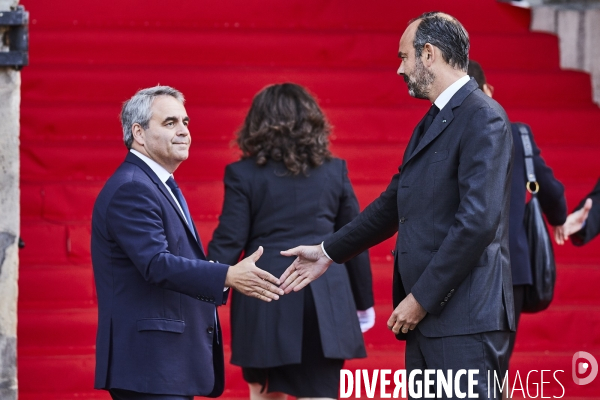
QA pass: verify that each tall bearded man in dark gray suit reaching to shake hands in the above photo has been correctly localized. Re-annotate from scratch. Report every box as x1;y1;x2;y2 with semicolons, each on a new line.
280;12;514;398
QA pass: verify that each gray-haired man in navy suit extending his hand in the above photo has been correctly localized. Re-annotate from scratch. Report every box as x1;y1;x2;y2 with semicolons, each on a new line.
92;86;283;400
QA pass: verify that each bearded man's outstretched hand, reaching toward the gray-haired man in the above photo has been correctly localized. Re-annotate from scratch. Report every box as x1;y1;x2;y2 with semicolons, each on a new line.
279;245;332;293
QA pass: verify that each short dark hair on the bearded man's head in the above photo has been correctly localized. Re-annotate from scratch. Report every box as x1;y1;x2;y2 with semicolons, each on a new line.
410;11;469;72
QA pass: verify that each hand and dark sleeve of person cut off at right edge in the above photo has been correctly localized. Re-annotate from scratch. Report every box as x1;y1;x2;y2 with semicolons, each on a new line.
554;179;600;246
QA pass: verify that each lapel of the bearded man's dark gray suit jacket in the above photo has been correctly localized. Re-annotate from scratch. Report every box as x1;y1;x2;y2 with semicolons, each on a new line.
402;78;477;167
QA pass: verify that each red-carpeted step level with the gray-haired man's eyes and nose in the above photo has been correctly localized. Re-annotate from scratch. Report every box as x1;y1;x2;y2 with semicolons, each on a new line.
21;103;600;147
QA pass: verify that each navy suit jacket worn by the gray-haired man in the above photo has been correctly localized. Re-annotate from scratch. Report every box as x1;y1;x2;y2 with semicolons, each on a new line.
92;153;228;396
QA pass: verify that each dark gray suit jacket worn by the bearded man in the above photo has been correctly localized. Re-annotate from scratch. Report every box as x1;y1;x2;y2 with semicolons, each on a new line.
325;80;515;338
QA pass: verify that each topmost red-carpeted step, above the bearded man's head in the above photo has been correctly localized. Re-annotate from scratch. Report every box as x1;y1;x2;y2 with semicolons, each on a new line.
25;0;529;33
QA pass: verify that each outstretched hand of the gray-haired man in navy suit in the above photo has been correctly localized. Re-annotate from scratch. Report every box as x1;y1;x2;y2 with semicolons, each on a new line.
225;246;283;302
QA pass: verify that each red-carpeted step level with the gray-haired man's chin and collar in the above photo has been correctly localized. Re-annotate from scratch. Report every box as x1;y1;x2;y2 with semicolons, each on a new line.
21;138;600;185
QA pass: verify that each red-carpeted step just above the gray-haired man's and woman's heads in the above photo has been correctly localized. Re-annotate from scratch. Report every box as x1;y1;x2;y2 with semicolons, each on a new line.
23;66;591;108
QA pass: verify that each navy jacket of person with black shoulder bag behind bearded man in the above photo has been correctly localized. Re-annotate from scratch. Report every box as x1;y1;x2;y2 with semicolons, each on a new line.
508;124;567;285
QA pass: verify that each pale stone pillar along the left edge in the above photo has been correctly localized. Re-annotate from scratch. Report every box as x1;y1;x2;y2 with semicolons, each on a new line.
0;0;21;400
